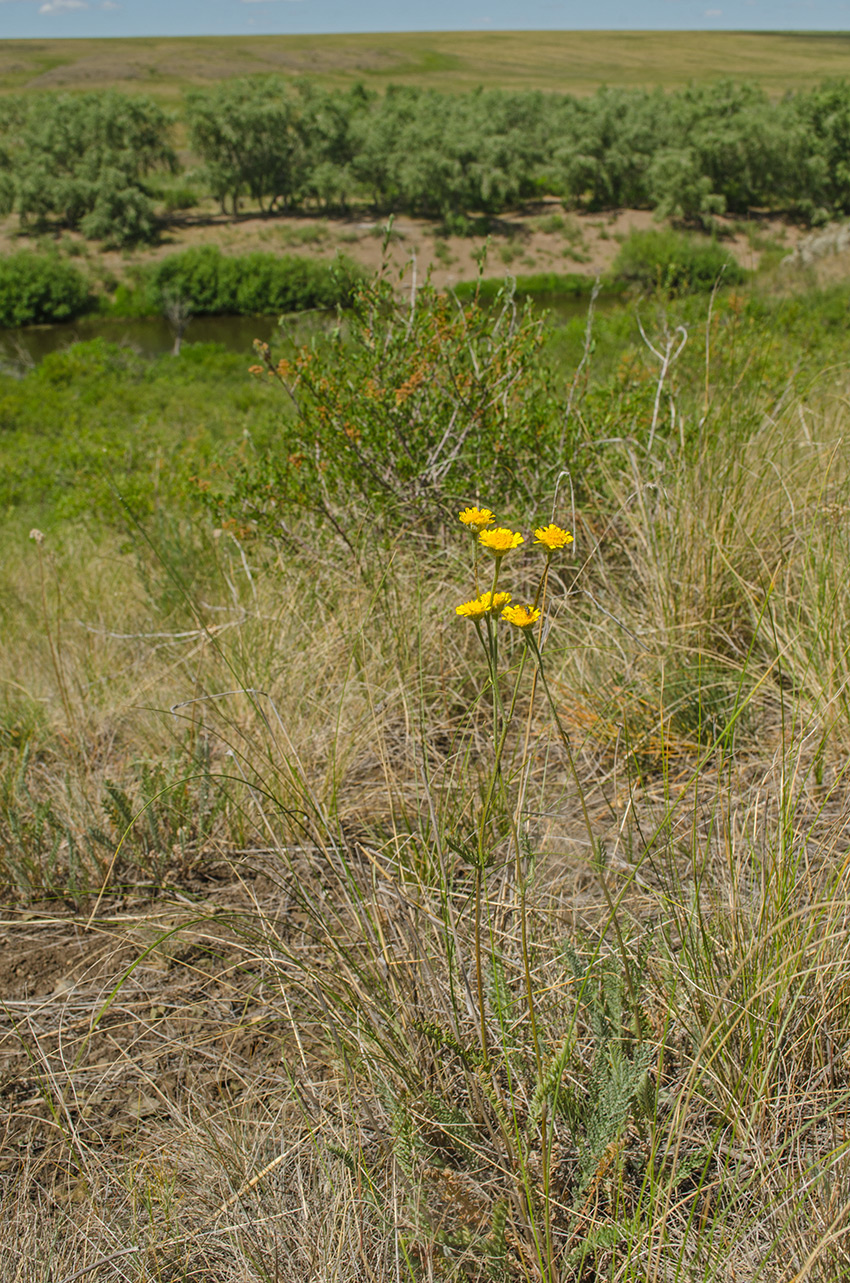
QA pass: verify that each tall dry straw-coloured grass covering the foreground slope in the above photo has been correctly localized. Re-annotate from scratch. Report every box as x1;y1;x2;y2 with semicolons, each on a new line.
0;286;850;1283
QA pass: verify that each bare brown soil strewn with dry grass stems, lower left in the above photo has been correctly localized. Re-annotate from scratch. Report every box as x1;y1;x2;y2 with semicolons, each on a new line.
0;879;292;1184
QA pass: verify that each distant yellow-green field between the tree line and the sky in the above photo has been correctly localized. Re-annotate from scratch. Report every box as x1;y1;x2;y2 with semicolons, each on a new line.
0;31;850;98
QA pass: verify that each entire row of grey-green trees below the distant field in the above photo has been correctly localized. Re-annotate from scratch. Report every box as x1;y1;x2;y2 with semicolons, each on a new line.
0;77;850;244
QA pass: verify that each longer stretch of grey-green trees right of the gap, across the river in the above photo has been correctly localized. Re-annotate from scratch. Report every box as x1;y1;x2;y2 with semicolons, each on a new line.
186;77;850;226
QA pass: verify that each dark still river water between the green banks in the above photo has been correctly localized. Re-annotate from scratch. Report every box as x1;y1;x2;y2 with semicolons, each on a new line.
0;295;605;368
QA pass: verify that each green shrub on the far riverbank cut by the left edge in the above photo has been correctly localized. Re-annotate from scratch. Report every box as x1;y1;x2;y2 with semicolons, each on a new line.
0;250;91;326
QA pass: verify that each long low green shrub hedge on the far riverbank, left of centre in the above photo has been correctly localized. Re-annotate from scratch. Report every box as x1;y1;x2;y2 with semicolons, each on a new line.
115;245;362;316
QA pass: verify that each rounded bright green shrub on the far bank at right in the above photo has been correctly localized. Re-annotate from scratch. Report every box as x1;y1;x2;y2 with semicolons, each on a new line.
614;231;746;294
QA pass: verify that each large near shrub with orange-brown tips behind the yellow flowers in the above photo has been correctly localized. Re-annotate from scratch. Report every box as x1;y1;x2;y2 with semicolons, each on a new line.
208;277;558;539
